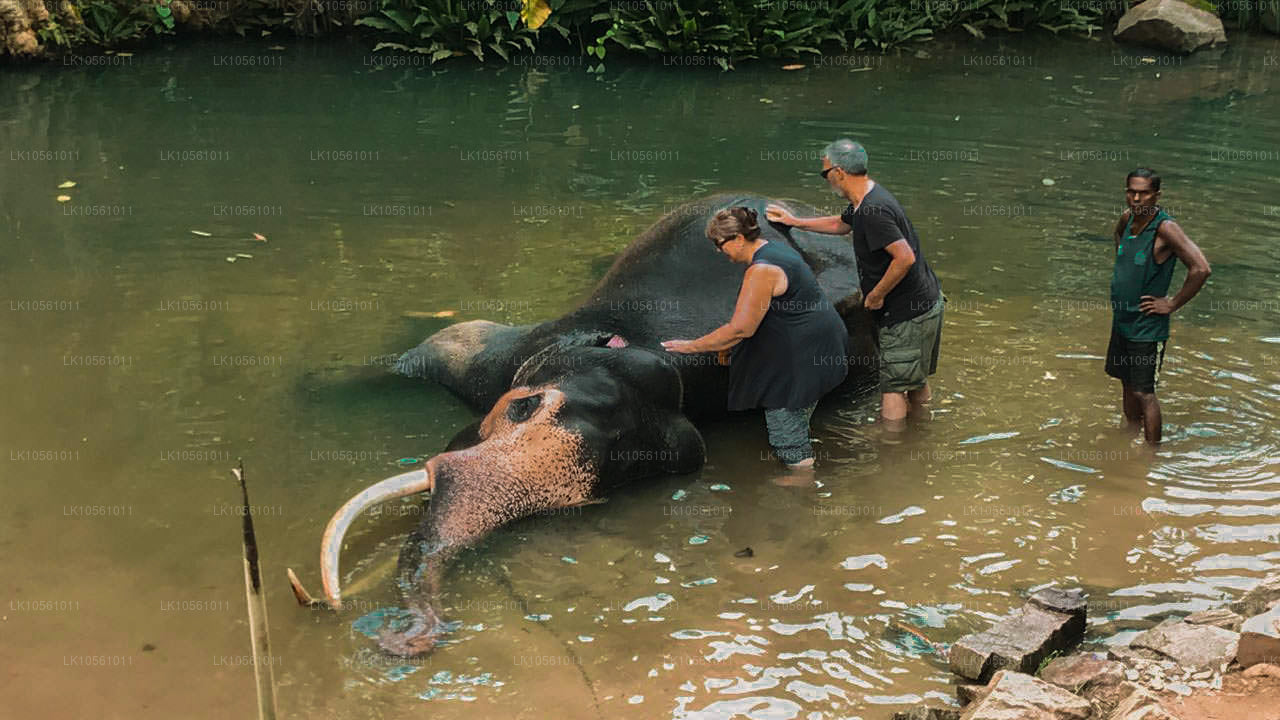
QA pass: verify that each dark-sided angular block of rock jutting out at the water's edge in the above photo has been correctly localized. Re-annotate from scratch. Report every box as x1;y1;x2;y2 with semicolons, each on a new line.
950;603;1084;683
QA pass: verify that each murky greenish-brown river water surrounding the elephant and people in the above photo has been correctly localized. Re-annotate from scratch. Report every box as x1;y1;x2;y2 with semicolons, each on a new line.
0;32;1280;720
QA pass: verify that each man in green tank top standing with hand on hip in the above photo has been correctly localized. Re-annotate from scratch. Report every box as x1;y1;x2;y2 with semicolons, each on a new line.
1106;168;1210;445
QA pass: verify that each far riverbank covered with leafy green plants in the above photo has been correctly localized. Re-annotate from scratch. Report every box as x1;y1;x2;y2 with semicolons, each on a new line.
0;0;1280;64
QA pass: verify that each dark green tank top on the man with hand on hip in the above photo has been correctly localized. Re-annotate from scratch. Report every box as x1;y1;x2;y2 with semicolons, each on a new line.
1111;208;1178;342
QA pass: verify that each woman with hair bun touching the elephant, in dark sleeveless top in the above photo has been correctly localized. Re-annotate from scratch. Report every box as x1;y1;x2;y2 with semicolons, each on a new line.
662;206;849;468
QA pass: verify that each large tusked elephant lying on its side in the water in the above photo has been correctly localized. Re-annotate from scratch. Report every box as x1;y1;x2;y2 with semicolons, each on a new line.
296;195;876;656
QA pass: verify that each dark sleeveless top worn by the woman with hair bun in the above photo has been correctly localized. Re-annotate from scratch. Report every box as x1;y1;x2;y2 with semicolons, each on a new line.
728;242;849;410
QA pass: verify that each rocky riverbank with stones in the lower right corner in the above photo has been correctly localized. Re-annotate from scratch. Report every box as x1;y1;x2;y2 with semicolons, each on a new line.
895;574;1280;720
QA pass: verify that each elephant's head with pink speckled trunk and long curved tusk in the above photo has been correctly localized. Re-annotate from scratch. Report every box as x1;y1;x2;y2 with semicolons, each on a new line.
312;334;705;656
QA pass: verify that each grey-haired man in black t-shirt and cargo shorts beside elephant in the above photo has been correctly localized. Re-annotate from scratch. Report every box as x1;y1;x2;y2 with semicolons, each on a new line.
765;138;943;424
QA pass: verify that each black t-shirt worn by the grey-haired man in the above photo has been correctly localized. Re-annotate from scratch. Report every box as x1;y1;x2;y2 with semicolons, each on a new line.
840;183;938;328
